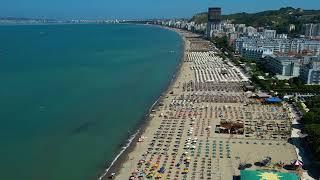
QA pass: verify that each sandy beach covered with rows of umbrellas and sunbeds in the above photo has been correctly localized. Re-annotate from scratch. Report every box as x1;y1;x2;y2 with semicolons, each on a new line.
103;27;297;180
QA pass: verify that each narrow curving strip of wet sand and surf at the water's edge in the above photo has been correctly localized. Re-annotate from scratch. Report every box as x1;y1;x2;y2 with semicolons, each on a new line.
98;25;186;180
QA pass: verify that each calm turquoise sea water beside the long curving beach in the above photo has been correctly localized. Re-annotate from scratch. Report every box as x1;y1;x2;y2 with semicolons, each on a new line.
0;25;182;180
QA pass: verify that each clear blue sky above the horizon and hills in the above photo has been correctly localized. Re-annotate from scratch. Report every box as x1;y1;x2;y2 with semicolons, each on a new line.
0;0;320;19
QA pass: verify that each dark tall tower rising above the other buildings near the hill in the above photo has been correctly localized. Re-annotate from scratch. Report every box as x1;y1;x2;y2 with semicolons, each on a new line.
207;7;221;38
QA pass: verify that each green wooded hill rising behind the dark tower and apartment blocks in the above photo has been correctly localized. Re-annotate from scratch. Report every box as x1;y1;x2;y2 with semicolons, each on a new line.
192;7;320;32
